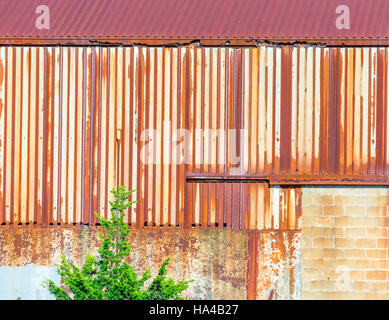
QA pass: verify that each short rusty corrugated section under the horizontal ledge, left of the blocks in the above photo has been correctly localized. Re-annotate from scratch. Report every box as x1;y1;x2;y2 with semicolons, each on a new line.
183;182;301;230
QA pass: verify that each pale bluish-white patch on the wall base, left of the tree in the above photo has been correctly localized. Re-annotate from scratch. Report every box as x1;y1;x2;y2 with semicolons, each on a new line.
0;264;60;300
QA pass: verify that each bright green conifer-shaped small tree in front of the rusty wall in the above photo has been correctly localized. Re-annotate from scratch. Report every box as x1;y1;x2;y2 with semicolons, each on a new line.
44;186;192;300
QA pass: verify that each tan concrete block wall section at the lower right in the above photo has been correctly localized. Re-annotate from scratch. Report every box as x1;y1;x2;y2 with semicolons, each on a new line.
301;186;389;299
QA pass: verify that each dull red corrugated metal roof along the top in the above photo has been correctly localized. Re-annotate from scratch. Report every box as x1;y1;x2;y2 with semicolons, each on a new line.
0;0;389;40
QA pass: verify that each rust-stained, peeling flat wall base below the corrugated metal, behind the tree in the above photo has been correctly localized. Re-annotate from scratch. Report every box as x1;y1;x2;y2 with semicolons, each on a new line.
0;226;301;299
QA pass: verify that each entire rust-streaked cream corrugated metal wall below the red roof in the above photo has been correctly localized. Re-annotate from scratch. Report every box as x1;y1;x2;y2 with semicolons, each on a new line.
0;46;389;229
